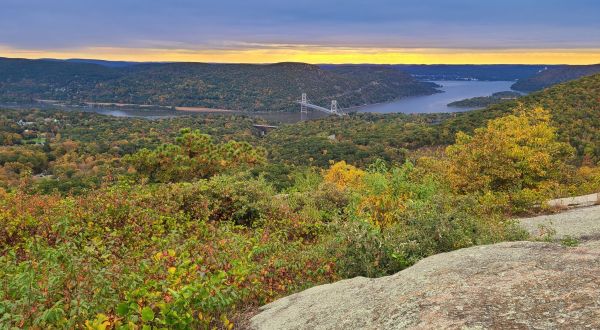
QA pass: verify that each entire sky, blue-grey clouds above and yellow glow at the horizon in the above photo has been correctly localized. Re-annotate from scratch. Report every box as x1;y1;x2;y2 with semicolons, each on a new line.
0;0;600;64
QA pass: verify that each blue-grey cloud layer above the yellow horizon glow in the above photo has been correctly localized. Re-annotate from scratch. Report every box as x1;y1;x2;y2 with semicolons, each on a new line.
0;0;600;51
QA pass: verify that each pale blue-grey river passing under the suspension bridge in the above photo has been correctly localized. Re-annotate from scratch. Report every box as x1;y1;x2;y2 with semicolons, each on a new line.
2;81;514;123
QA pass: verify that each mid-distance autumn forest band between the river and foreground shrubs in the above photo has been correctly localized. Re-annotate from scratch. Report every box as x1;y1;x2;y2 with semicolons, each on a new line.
0;75;600;195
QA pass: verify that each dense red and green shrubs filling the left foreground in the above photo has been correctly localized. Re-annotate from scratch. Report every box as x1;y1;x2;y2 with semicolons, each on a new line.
0;175;338;329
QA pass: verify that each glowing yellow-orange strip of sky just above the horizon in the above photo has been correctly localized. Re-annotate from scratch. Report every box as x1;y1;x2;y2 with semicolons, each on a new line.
0;46;600;64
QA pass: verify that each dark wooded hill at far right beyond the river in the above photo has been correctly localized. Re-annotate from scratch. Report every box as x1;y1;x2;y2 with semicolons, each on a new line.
512;64;600;92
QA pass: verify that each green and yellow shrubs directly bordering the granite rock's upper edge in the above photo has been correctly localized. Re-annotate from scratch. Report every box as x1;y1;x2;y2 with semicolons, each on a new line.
328;163;526;277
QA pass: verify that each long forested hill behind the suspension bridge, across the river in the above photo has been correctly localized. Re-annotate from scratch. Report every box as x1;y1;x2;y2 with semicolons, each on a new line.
0;58;436;111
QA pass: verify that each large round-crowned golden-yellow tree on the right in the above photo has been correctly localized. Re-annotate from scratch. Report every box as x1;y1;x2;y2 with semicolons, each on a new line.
446;108;574;193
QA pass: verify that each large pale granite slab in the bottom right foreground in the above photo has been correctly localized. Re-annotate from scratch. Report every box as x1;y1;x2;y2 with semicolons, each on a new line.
250;241;600;330
